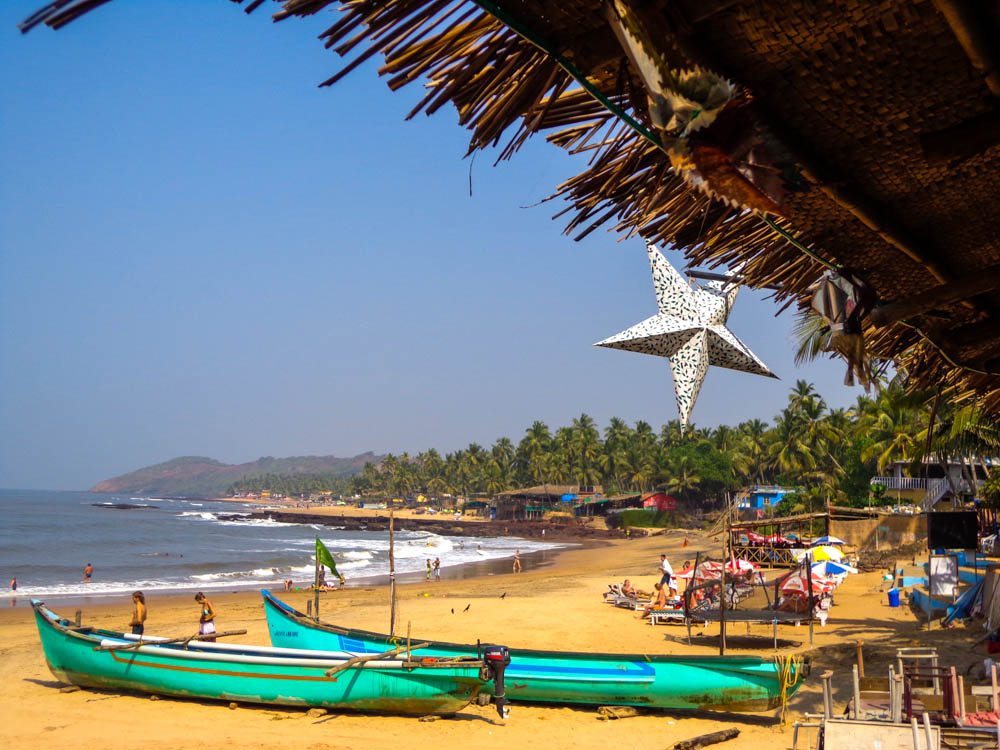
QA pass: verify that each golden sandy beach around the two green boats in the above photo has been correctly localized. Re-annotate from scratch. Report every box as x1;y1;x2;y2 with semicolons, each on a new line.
0;531;980;750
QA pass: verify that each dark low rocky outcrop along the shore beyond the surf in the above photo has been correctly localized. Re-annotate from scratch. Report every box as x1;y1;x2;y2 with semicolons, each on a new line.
218;510;624;540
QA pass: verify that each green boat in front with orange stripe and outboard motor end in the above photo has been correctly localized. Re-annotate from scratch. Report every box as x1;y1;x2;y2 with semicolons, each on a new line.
32;600;502;716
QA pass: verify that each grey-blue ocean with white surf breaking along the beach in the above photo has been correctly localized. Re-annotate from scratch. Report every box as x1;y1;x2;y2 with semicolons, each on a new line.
0;490;565;601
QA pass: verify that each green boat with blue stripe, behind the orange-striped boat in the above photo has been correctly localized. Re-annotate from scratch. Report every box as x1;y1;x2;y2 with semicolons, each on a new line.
261;591;808;711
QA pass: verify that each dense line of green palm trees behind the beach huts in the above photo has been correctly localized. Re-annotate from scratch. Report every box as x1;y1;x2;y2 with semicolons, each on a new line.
230;379;1000;511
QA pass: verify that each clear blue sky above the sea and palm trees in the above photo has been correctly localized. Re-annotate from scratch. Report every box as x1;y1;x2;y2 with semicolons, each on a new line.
0;0;857;489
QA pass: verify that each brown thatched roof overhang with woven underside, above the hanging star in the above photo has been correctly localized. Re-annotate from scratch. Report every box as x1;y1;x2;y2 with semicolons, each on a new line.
27;0;1000;413
